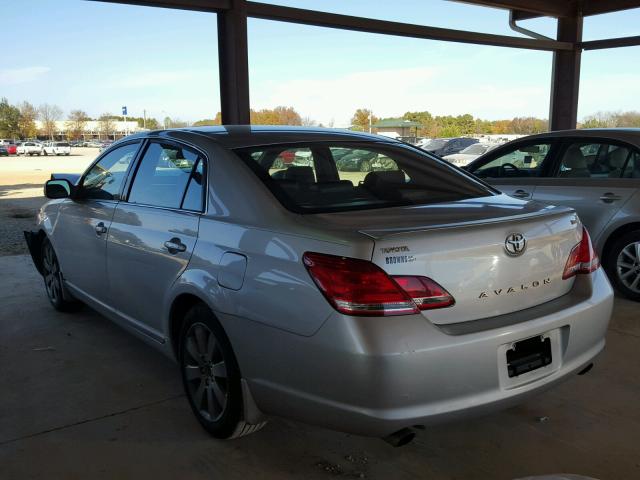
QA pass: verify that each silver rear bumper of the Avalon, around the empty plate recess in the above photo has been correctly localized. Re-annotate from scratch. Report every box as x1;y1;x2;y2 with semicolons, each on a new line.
231;269;613;436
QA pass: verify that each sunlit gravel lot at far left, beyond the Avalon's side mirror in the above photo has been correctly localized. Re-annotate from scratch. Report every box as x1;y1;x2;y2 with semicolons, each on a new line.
0;148;98;256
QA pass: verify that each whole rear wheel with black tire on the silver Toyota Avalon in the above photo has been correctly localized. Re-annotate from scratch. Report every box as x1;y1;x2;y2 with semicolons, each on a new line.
178;304;266;439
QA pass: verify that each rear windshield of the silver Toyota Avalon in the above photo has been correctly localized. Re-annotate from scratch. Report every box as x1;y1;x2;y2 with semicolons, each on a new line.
235;142;493;213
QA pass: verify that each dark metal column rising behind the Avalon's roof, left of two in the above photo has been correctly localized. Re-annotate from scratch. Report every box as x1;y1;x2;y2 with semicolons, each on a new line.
218;0;250;125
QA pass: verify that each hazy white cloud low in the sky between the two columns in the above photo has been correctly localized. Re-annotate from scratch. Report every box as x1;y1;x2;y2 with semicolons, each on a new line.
252;66;549;126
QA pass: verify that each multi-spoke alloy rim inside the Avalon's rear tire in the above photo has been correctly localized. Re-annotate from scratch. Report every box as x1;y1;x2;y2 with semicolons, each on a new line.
182;322;229;422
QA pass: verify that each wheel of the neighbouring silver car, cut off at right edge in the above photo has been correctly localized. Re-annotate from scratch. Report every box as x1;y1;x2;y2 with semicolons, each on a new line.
604;230;640;302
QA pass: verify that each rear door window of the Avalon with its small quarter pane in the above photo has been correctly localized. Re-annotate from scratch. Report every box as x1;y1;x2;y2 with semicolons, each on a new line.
128;142;203;210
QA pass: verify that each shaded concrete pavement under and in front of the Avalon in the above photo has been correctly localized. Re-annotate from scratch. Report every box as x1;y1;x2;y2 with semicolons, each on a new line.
0;255;640;480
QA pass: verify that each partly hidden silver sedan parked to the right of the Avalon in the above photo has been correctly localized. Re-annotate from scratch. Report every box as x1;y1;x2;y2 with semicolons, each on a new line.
467;128;640;301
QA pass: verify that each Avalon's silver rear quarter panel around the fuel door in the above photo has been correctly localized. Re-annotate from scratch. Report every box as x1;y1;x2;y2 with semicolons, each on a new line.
176;219;373;336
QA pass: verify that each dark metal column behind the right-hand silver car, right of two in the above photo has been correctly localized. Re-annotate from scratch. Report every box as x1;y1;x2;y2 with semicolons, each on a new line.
549;15;582;130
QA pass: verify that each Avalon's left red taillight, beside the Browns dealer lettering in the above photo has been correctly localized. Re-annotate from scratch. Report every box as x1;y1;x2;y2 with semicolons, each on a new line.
303;252;453;316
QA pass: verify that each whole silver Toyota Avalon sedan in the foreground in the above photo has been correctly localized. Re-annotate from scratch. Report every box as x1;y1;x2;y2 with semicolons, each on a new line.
25;126;613;444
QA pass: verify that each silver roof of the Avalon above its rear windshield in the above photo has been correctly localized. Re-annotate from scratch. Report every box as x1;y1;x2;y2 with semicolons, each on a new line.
122;125;401;148
